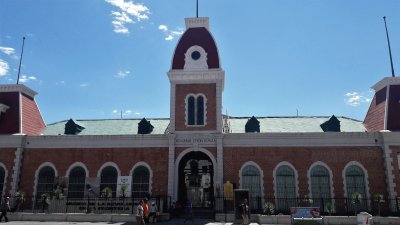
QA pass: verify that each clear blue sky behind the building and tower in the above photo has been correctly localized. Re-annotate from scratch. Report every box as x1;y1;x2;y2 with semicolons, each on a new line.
0;0;400;123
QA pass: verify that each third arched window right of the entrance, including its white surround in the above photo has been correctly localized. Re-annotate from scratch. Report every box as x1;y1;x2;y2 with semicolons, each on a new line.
307;161;334;209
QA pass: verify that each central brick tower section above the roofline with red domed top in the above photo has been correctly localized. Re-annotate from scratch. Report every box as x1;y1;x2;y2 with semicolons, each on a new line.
168;17;225;133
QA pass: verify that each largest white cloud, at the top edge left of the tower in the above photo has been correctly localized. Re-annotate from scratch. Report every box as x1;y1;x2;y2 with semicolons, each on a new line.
105;0;150;34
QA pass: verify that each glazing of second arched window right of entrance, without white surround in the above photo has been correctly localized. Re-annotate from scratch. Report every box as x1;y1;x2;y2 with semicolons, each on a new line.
276;165;297;211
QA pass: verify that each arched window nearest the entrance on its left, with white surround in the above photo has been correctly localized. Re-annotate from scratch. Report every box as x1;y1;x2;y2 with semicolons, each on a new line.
130;162;153;198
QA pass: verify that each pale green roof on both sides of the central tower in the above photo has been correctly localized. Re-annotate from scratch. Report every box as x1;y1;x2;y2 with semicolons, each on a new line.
43;116;366;135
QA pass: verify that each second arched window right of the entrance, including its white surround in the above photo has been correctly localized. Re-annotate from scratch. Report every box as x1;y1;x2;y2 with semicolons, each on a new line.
274;162;298;211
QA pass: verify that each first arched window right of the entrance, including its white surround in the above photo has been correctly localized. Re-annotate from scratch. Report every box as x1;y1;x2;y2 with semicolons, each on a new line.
239;161;264;209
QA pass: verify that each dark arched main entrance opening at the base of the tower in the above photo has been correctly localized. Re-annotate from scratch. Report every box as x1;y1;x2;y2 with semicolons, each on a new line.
178;151;214;207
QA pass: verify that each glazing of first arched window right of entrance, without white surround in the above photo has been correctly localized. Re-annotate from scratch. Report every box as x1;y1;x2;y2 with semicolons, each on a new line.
240;165;261;209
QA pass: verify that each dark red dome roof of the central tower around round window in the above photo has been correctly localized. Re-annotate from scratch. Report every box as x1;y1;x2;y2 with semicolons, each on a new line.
172;27;220;70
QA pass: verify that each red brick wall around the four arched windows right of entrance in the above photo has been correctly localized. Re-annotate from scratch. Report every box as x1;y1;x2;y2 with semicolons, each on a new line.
224;147;387;198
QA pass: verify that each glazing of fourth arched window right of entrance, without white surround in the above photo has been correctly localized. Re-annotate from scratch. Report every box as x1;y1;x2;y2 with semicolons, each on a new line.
346;165;368;210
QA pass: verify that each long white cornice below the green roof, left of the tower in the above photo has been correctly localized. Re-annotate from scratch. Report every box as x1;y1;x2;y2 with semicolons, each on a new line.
26;135;168;148
